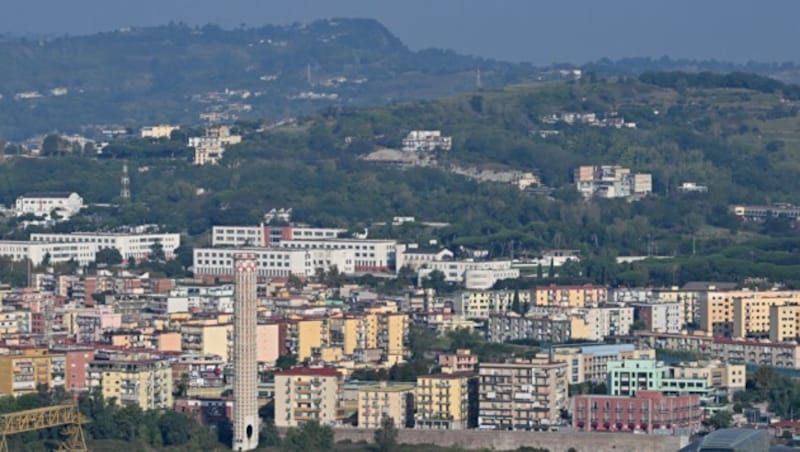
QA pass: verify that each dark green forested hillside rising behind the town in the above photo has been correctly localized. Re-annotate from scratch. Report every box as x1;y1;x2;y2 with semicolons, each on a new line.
0;75;800;284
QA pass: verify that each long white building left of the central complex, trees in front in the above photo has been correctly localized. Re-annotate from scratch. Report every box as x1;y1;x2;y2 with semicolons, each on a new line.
31;232;181;261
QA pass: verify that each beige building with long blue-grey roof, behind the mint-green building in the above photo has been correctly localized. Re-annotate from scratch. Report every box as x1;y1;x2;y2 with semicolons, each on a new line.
553;344;656;384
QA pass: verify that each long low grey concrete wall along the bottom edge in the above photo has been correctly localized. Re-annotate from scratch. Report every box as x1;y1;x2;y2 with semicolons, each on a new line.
335;428;688;452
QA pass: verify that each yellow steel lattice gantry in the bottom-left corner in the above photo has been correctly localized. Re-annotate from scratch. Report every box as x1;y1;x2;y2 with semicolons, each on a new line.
0;405;89;452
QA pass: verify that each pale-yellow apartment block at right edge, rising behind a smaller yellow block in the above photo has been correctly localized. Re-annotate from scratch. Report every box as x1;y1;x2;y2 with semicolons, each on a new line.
698;290;800;338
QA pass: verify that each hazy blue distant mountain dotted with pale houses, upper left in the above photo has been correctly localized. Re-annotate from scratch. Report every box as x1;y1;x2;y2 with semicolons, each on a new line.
0;19;557;139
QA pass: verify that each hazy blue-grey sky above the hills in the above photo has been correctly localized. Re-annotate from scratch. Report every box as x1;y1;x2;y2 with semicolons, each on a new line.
0;0;800;64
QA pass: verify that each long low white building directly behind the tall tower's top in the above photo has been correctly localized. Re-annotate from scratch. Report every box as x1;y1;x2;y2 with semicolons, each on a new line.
193;247;355;277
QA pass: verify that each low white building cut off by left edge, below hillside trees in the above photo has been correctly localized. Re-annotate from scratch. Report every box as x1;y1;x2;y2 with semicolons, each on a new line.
0;240;96;266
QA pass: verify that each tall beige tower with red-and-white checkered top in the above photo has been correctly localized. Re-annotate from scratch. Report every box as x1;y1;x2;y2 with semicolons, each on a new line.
233;253;259;451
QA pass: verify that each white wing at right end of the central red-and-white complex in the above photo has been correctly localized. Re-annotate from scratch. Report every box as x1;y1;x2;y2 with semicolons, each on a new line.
277;239;397;272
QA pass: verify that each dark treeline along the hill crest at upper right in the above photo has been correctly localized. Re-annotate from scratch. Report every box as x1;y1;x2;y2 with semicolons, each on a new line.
639;72;800;100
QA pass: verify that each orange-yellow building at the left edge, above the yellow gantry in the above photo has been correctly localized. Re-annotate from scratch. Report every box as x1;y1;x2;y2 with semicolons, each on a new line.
0;348;53;396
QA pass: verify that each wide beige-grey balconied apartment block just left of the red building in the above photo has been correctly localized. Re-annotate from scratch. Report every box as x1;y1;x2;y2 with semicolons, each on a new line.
478;360;567;430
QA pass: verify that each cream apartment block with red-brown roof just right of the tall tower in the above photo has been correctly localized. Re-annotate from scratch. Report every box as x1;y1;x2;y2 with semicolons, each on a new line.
275;367;343;427
